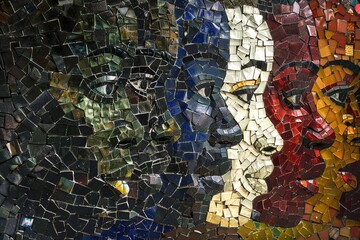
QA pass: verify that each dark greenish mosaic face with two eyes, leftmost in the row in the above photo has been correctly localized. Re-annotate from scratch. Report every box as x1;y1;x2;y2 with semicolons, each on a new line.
50;3;180;195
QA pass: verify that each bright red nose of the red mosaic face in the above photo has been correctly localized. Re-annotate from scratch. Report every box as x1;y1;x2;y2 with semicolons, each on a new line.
303;113;335;150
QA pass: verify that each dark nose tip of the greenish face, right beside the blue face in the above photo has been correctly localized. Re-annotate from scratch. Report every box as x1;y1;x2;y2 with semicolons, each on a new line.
150;111;181;144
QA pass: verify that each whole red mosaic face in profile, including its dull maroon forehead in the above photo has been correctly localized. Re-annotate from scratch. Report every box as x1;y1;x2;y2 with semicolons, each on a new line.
253;1;334;227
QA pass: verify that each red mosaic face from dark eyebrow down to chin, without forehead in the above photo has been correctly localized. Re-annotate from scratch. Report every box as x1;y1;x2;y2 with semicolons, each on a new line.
254;62;334;227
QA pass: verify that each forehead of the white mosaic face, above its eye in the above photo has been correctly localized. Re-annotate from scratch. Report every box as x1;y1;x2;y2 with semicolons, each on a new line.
225;5;274;83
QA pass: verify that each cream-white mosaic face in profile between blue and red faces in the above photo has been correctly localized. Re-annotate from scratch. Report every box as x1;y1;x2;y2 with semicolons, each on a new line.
207;6;283;227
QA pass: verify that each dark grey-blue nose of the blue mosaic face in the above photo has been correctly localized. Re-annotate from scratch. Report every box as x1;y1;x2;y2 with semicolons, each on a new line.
209;106;243;147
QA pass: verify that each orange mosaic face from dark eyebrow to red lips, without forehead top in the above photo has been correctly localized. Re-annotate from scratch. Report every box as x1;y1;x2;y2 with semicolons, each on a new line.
313;61;360;194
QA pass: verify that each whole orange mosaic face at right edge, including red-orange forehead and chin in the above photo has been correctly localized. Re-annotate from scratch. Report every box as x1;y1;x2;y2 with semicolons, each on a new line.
306;0;360;223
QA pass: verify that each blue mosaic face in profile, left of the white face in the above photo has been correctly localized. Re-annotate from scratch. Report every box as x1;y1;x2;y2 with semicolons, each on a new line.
166;1;242;176
